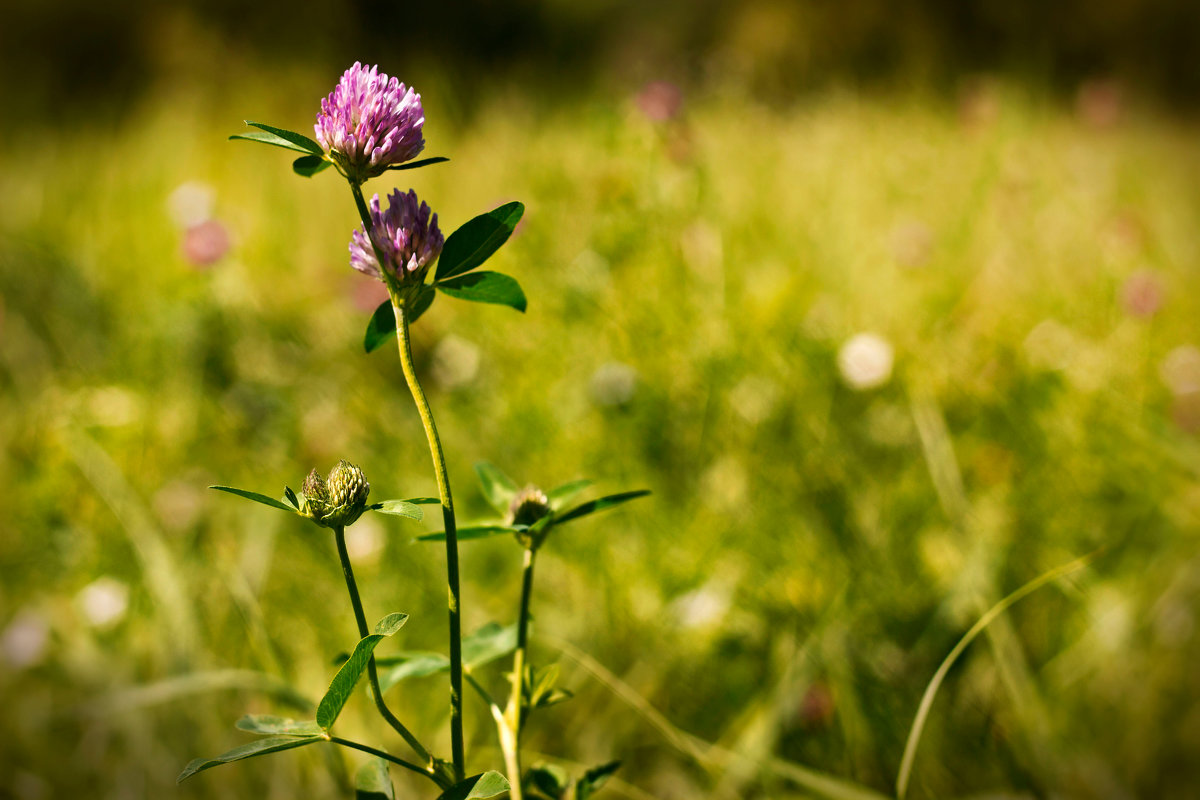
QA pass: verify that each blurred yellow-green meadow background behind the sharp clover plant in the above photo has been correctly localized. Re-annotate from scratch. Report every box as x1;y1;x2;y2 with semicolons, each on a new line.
0;0;1200;800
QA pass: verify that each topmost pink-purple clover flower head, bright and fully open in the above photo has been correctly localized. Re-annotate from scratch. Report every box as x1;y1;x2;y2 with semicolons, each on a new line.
314;61;425;184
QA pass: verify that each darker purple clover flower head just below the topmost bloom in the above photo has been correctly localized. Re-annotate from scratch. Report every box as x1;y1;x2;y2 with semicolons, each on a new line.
350;190;445;283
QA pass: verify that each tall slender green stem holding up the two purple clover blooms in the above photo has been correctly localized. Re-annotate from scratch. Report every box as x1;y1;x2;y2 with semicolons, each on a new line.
350;181;466;781
